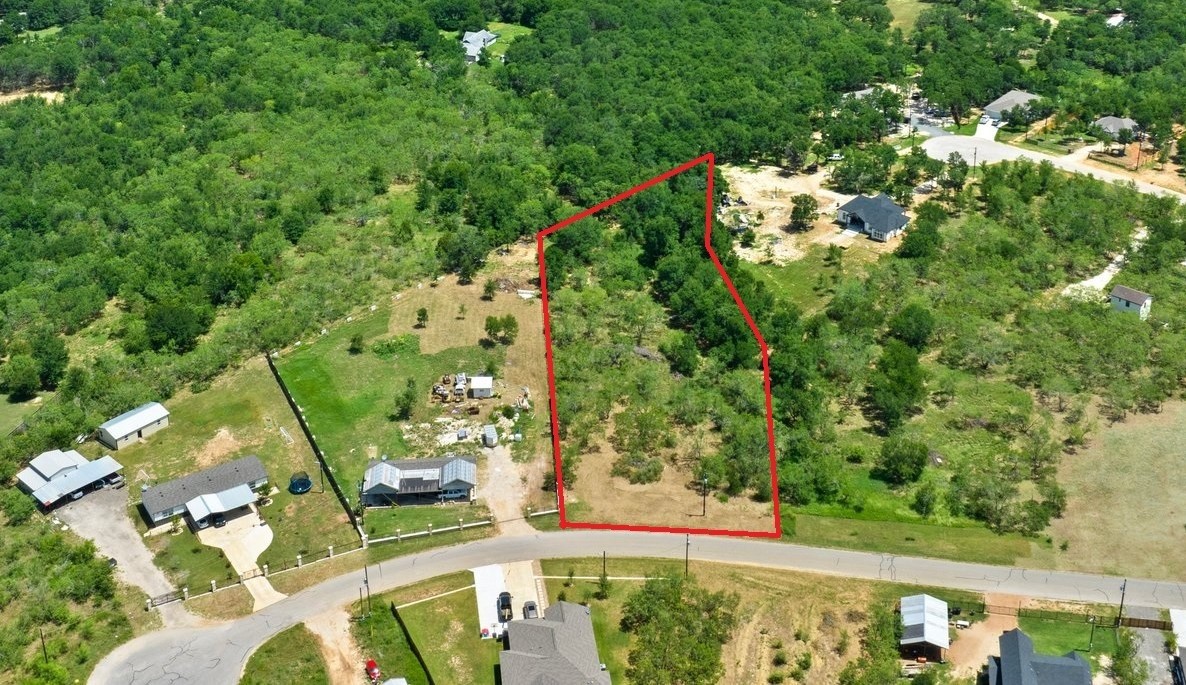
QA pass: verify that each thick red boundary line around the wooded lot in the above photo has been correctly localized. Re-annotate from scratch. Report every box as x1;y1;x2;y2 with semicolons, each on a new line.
535;153;783;538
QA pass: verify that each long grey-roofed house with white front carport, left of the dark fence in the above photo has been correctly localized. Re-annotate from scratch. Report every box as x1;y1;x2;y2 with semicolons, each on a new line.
140;455;268;527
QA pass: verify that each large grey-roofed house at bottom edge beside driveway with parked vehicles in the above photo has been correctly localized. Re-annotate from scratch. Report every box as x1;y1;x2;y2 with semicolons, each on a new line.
498;602;610;685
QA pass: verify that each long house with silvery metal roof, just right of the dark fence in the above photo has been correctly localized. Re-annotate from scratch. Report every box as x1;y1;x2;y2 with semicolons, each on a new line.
362;454;478;506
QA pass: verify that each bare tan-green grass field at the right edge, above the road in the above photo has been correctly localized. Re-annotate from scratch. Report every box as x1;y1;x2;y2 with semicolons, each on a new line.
1051;399;1186;578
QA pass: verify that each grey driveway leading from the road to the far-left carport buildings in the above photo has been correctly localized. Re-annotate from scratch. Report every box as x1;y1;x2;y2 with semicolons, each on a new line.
53;487;197;627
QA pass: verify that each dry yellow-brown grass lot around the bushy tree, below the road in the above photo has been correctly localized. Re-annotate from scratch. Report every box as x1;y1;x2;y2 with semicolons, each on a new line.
542;558;980;684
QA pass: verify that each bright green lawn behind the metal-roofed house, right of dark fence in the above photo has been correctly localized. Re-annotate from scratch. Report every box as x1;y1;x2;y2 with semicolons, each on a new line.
276;308;505;489
